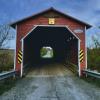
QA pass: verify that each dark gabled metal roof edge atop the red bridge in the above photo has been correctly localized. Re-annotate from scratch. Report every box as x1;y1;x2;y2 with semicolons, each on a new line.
10;7;92;29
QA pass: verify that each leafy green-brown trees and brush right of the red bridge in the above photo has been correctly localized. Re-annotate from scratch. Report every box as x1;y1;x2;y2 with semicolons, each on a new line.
87;27;100;72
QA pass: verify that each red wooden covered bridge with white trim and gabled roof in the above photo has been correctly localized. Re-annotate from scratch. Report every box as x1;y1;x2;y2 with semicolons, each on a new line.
11;8;91;76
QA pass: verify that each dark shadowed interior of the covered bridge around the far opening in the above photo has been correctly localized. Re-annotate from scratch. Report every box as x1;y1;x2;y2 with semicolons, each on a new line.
23;26;78;66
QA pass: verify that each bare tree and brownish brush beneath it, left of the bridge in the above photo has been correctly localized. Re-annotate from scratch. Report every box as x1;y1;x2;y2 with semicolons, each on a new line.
0;25;15;72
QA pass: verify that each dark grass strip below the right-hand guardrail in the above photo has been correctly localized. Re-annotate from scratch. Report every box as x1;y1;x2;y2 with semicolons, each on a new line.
82;76;100;88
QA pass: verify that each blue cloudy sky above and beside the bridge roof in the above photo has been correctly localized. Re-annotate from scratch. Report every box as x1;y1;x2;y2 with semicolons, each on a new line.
0;0;100;48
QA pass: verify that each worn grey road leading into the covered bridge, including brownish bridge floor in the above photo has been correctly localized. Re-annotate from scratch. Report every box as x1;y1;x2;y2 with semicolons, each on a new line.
0;64;100;100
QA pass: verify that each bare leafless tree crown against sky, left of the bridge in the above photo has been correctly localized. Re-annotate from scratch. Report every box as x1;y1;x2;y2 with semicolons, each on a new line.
0;25;14;48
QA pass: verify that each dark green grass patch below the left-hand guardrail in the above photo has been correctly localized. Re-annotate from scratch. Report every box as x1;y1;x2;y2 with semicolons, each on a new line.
0;78;17;95
